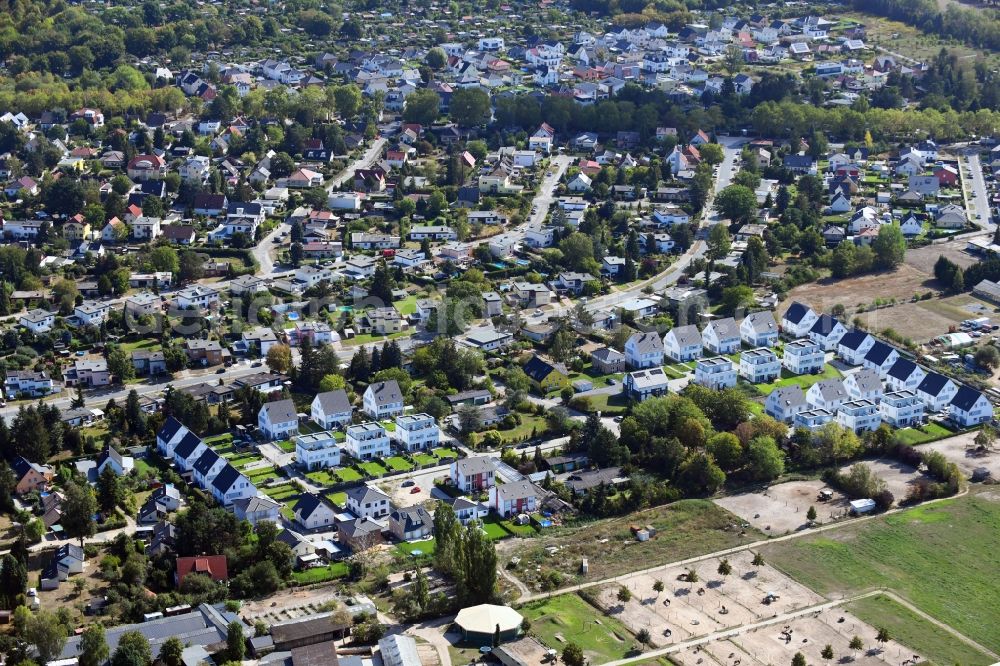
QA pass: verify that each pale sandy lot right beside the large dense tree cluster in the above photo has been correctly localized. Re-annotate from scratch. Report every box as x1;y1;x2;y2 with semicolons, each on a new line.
714;479;848;536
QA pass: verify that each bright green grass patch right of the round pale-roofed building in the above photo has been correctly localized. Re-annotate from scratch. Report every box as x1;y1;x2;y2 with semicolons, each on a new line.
518;594;638;664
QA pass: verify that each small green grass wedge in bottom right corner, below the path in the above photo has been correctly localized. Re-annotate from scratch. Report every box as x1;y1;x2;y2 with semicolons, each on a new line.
846;596;993;666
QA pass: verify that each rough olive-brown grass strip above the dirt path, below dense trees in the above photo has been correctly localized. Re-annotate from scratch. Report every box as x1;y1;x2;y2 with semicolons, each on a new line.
510;500;763;587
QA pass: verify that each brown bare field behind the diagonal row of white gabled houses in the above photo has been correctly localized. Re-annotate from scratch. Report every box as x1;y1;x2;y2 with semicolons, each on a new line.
778;263;937;315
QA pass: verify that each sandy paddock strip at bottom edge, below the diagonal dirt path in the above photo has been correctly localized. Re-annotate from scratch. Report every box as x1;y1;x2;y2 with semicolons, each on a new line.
670;607;923;666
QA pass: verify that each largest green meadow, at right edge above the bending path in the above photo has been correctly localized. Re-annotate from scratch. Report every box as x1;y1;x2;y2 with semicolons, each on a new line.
764;493;1000;652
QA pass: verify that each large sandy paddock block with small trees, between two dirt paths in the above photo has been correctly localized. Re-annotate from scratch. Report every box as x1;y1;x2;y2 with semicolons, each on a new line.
598;551;823;647
